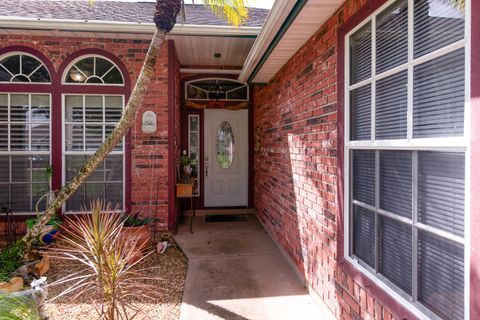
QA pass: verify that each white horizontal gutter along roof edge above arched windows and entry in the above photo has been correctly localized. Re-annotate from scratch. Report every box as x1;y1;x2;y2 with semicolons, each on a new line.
0;16;262;36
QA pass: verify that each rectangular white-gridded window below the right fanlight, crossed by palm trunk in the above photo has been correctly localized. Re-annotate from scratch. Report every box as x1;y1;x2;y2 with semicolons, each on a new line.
64;94;125;212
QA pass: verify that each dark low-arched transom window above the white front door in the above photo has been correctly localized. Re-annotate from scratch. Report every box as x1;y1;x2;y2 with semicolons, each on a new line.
185;78;248;101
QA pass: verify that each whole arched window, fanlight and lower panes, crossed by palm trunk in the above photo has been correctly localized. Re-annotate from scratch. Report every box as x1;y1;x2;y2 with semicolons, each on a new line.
63;55;125;212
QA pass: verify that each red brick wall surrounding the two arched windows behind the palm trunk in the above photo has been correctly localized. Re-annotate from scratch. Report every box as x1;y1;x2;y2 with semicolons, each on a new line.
0;30;172;230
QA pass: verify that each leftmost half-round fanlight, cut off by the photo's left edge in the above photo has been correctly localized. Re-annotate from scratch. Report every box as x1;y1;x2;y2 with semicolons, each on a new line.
0;52;50;83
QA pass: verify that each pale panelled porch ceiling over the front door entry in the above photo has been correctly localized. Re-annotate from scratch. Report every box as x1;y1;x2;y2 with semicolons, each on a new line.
172;35;255;69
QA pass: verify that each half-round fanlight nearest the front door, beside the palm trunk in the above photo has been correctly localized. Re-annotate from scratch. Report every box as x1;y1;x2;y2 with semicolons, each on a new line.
63;55;124;85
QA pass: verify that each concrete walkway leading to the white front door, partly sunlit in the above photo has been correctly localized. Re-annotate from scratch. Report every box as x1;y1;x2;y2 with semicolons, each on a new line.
174;215;332;320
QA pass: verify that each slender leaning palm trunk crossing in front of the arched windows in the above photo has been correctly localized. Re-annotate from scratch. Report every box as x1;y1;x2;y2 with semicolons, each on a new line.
20;28;166;252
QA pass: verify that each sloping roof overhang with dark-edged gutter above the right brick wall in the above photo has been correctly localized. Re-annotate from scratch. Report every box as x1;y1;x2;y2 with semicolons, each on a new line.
238;0;344;83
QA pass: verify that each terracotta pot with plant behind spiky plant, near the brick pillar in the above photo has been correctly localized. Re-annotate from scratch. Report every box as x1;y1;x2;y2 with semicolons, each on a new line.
120;212;153;263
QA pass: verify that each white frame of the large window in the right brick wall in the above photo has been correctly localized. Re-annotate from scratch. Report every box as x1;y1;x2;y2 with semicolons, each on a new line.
341;0;471;320
